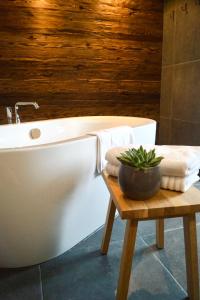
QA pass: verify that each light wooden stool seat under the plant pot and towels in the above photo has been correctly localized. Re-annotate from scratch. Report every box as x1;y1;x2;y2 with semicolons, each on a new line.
102;171;200;220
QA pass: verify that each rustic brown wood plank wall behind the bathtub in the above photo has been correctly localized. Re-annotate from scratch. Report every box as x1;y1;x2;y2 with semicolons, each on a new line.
0;0;163;124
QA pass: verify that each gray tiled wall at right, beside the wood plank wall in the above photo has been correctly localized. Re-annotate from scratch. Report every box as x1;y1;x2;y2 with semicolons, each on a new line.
159;0;200;145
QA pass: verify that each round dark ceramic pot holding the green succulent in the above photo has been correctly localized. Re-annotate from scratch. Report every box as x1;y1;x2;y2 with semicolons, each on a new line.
118;164;161;200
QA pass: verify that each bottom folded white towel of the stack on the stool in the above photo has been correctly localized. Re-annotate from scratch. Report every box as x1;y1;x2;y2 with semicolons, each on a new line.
105;163;199;192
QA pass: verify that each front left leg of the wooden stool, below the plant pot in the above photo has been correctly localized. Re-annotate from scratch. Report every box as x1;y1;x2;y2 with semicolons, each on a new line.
116;220;138;300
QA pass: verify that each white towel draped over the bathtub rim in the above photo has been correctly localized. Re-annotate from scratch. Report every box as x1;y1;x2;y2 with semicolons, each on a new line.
89;126;135;173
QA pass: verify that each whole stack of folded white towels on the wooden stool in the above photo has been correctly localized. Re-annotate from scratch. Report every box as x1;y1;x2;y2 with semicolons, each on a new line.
105;145;200;192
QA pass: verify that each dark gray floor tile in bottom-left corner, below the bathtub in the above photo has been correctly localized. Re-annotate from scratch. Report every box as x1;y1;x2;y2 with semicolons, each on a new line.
0;266;42;300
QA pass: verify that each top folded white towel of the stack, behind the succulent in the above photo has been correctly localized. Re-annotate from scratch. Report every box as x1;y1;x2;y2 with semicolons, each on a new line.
105;145;200;177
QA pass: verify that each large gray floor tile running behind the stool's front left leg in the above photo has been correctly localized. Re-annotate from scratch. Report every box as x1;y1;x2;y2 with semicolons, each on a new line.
41;219;185;300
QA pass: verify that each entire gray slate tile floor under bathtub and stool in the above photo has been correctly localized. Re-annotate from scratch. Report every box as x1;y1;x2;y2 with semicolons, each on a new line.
0;182;200;300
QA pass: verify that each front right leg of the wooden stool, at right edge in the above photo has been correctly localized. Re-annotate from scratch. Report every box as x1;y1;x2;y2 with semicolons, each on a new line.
183;214;200;300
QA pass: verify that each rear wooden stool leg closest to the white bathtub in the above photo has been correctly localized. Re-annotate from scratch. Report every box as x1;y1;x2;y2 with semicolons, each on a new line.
101;197;116;254
